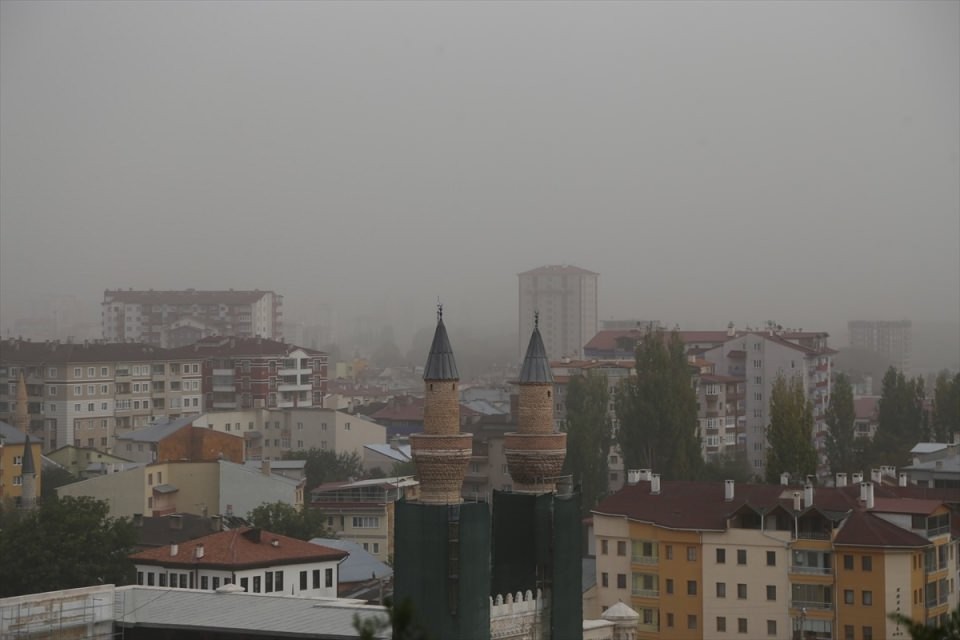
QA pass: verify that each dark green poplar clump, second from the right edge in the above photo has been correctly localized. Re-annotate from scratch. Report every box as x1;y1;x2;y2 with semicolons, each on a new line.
867;367;930;466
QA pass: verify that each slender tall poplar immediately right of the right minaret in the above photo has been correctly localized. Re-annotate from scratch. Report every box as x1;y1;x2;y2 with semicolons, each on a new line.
563;372;613;513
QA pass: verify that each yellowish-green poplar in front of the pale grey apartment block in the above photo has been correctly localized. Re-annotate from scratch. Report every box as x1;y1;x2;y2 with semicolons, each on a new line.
767;375;817;483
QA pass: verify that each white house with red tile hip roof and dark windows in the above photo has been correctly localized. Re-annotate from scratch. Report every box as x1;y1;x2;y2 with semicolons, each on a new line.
130;527;348;598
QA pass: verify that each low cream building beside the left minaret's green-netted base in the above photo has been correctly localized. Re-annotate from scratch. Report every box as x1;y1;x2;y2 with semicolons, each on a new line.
310;476;420;562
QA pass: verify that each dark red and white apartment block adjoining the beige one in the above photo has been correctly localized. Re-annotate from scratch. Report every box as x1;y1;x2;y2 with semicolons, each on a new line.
169;337;327;411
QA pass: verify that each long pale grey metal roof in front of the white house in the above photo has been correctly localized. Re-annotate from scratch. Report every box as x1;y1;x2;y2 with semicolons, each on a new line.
117;586;390;640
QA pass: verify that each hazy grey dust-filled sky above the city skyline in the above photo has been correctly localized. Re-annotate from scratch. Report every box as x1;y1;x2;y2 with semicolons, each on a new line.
0;0;960;344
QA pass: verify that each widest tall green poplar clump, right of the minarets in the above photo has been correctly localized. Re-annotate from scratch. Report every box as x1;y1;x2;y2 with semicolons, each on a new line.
615;329;703;478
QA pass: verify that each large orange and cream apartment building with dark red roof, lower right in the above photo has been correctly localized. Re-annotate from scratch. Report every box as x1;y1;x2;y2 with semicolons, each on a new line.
593;470;960;640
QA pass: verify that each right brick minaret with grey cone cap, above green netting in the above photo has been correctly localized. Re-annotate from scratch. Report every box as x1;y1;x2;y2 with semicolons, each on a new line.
503;314;567;493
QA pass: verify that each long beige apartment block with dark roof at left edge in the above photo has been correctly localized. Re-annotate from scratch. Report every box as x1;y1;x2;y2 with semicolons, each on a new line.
0;340;203;451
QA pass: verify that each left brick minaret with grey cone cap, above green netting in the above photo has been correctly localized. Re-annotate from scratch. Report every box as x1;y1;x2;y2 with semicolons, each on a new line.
410;308;473;504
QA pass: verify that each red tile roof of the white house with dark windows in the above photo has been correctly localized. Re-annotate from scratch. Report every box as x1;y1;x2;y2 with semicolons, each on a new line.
130;527;348;569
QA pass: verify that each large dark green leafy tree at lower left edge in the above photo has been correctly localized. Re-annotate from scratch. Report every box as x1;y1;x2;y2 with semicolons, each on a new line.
0;496;137;598
